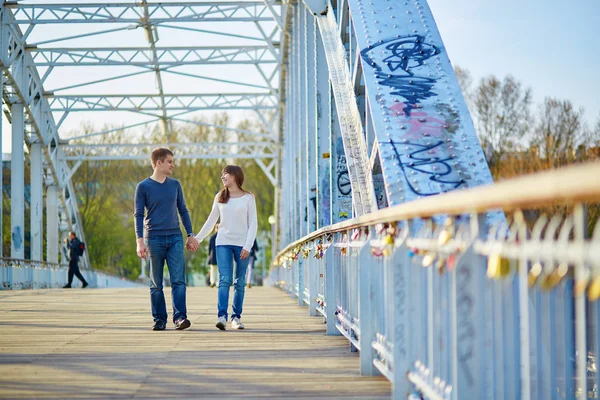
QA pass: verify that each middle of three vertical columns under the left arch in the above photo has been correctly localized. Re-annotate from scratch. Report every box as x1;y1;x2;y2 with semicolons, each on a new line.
30;143;44;261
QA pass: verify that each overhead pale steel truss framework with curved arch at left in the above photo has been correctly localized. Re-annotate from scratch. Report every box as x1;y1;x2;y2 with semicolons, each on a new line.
0;0;284;264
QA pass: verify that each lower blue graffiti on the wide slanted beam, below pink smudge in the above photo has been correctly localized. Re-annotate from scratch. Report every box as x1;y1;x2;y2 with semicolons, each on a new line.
381;140;466;196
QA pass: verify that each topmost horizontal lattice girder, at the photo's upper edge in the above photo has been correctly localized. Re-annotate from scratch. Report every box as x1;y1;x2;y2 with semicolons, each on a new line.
5;1;282;25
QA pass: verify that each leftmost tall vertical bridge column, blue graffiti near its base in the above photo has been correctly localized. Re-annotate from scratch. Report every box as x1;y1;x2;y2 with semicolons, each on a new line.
10;103;25;259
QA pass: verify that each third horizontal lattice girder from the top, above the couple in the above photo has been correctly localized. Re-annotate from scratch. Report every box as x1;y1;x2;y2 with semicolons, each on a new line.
48;93;277;112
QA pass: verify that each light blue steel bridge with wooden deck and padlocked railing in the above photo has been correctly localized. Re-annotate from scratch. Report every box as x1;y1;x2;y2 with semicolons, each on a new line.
0;0;600;399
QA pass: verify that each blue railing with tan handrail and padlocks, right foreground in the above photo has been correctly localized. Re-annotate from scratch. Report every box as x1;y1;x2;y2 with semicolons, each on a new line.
270;163;600;399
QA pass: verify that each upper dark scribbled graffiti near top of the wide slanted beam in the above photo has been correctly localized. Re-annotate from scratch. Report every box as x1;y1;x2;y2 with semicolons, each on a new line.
361;35;440;116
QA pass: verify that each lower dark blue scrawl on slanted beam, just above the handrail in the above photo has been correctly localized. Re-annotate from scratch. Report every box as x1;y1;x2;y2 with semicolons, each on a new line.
381;139;467;196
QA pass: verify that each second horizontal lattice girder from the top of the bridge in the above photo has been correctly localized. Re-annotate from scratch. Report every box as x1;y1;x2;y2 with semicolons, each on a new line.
27;46;279;67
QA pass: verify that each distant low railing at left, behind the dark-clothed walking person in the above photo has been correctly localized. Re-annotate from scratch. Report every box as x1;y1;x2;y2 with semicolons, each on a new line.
0;258;141;290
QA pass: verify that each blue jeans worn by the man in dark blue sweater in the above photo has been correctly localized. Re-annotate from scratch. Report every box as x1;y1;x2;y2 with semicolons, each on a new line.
146;234;187;323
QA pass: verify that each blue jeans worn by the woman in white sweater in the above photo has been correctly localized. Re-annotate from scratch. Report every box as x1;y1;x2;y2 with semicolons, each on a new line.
215;245;248;319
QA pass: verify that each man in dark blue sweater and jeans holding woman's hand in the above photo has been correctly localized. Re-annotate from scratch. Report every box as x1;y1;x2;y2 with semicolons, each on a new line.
134;148;198;331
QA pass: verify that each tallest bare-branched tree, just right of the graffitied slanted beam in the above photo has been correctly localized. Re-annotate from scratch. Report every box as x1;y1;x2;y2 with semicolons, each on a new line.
473;76;531;168
